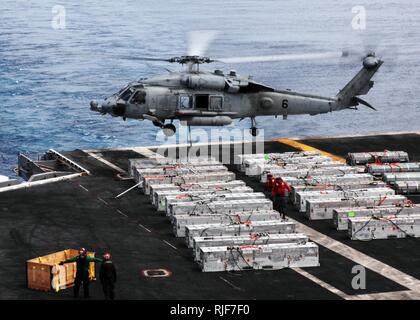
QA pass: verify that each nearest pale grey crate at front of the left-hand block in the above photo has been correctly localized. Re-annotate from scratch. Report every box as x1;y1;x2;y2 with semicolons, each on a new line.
199;242;319;272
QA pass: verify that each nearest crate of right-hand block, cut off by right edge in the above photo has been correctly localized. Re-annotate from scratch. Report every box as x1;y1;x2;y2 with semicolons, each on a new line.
348;215;420;241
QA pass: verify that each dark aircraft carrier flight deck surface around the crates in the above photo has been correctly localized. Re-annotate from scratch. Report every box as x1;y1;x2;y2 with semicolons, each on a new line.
0;133;420;300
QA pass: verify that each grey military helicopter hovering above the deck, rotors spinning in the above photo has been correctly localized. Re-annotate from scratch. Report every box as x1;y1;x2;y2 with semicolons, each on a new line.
90;34;383;136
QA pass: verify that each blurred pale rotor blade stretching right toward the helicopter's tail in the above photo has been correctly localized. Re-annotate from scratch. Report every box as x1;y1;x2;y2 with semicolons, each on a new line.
215;51;346;63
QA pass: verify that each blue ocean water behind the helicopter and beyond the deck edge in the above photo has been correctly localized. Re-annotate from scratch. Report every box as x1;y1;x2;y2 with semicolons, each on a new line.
0;0;420;176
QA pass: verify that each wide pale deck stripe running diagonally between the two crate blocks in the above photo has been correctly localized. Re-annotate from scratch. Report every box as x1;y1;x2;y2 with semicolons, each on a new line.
289;218;420;295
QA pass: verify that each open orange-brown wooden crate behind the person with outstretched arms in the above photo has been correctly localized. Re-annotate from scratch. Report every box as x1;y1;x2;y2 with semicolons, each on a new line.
26;249;96;291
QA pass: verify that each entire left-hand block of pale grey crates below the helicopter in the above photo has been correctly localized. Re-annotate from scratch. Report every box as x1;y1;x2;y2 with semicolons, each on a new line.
129;158;319;272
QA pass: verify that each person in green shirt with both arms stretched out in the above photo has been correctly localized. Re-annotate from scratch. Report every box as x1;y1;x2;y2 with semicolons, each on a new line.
60;248;102;298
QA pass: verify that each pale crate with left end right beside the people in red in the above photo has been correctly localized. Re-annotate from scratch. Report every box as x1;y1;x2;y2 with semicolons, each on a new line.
296;187;395;212
